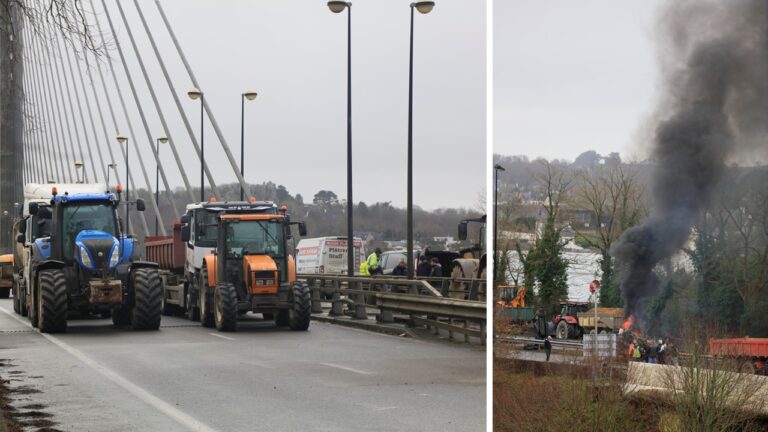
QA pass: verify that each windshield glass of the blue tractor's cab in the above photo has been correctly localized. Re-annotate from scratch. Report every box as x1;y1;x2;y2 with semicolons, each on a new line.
62;202;117;259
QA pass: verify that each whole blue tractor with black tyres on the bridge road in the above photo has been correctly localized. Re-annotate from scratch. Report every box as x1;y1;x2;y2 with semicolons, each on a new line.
19;188;162;333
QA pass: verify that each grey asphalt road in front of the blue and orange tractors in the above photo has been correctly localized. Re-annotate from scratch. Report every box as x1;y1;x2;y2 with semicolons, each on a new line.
0;300;486;432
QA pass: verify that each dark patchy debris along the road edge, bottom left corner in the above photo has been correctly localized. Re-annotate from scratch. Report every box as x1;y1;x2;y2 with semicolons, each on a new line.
0;359;61;432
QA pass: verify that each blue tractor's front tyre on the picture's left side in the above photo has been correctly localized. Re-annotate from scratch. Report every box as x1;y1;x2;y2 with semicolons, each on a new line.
37;270;68;333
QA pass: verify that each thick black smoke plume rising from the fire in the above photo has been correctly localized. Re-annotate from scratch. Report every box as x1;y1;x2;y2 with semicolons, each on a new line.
611;0;768;315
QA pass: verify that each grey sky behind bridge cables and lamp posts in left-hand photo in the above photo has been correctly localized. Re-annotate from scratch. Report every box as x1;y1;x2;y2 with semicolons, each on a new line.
81;0;486;209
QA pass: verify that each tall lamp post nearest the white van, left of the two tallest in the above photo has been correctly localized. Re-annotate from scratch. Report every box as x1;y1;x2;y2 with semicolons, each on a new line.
328;1;355;276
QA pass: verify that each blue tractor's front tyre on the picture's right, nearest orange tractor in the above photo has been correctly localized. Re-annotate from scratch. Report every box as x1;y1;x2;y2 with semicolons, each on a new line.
131;268;163;330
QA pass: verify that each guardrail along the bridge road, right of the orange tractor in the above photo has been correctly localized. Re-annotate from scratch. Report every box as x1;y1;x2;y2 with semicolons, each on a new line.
297;274;487;344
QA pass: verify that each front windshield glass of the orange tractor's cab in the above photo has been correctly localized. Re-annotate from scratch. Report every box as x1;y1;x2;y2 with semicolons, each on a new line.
227;220;285;258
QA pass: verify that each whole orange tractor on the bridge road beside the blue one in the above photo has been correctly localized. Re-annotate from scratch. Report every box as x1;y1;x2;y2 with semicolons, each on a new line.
189;211;311;331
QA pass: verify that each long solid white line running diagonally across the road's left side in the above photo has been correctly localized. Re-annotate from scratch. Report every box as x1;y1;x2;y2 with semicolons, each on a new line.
0;307;218;432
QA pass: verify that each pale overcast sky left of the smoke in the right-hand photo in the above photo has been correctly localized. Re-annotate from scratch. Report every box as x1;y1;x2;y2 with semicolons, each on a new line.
493;0;661;160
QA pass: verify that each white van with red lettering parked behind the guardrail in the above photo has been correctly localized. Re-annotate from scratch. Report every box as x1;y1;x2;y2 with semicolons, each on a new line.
296;237;366;274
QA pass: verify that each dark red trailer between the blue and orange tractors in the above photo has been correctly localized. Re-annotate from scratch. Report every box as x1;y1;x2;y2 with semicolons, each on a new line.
144;221;186;315
